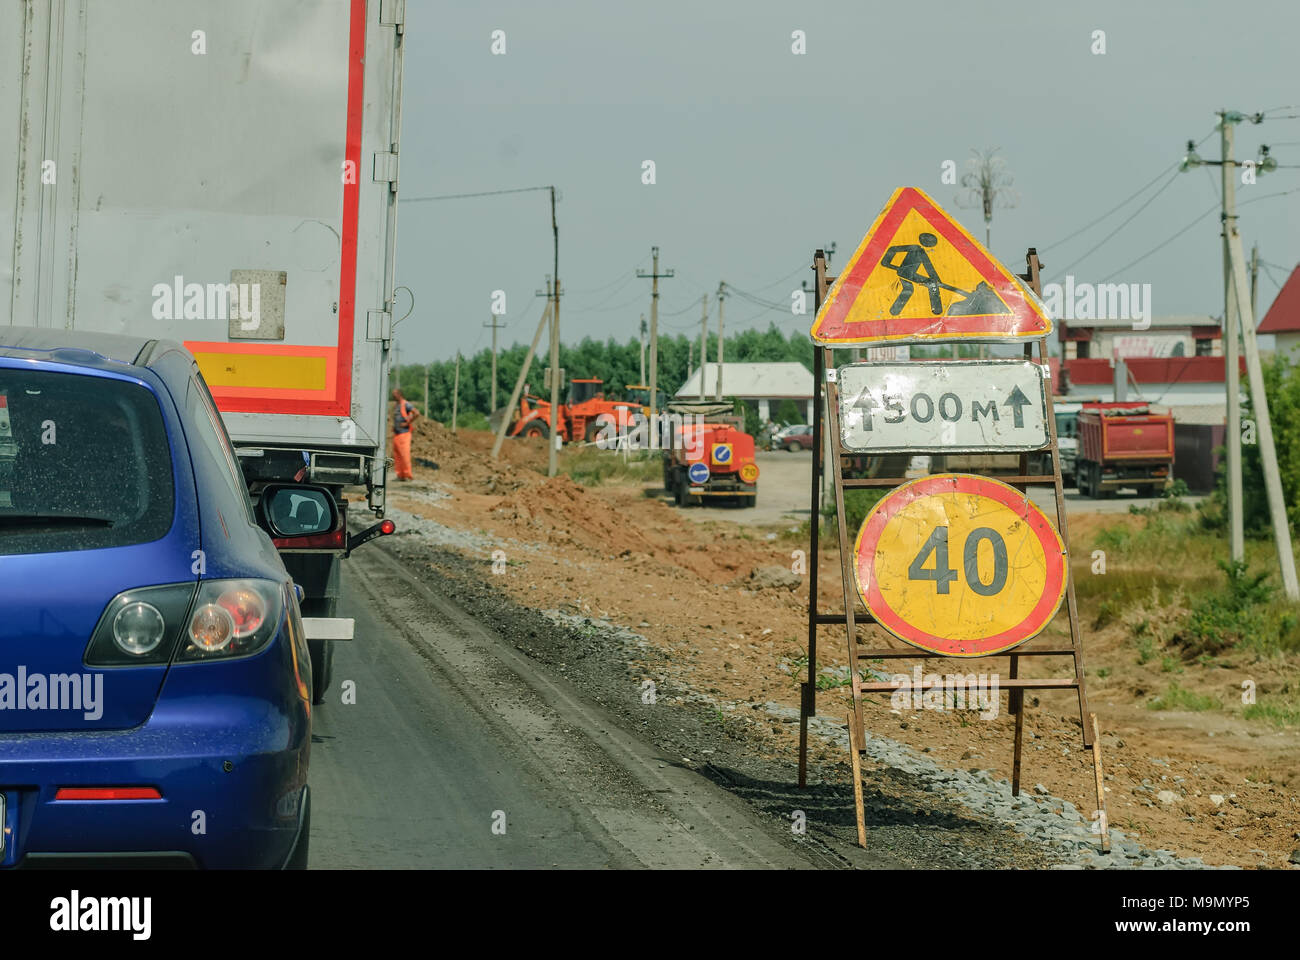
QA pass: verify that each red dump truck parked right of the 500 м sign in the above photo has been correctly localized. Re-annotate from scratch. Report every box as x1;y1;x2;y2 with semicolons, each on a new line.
1075;403;1174;500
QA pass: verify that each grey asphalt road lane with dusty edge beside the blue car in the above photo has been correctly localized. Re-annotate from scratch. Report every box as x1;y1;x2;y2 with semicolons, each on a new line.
309;545;813;869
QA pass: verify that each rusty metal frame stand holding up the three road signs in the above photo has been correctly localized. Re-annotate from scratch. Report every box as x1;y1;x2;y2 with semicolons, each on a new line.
800;247;1110;852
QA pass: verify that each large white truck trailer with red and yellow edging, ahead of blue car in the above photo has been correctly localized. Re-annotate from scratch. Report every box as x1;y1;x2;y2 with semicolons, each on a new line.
0;0;406;702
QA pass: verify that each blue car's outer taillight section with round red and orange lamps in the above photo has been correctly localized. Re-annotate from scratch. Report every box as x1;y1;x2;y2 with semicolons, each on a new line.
177;580;285;662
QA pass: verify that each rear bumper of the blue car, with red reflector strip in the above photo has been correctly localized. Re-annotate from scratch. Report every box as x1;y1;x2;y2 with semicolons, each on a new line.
0;696;311;869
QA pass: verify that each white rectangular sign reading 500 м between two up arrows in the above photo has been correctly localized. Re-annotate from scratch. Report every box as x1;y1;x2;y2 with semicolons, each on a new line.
839;360;1048;453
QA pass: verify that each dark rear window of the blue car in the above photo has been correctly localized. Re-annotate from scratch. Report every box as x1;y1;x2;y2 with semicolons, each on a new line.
0;368;174;555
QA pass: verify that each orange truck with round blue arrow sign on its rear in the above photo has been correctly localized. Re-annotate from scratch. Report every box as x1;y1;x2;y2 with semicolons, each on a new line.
663;401;758;507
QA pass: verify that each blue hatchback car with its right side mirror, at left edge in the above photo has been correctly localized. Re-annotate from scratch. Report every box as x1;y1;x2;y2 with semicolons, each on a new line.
0;327;327;868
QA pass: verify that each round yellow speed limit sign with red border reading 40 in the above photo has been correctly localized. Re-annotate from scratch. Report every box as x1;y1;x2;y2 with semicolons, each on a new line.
854;473;1066;657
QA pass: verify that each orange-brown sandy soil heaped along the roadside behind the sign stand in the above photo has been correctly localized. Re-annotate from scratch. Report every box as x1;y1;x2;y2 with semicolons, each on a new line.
390;421;1300;868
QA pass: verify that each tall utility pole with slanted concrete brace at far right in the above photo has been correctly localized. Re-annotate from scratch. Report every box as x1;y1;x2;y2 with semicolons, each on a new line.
1219;117;1300;602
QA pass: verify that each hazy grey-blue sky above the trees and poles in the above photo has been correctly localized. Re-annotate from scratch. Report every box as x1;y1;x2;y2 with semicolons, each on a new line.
397;0;1300;363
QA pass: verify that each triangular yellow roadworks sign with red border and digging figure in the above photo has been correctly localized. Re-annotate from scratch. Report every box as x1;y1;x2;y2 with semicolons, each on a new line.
811;187;1052;346
